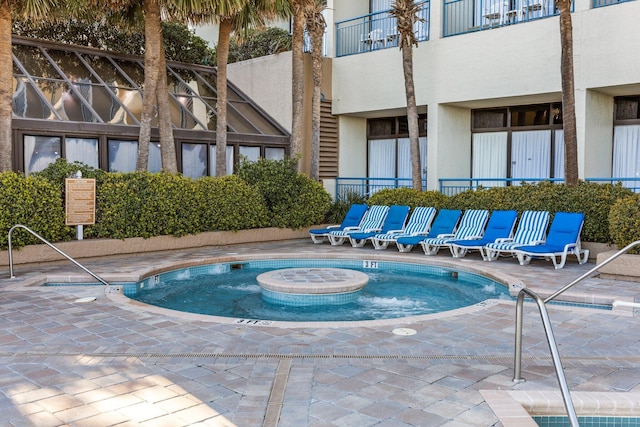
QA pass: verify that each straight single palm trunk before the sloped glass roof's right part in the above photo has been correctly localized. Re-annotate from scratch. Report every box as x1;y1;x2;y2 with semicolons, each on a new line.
216;18;231;176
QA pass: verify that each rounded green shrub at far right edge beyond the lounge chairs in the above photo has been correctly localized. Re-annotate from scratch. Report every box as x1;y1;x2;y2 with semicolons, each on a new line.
609;194;640;254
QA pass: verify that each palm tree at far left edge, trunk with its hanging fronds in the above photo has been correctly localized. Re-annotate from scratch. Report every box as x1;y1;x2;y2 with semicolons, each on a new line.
0;0;64;172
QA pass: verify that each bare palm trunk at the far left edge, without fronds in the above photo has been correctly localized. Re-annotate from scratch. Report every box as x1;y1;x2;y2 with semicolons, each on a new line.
0;4;13;172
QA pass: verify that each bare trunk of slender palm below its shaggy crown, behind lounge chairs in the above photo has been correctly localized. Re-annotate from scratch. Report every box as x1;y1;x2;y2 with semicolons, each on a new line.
402;45;422;190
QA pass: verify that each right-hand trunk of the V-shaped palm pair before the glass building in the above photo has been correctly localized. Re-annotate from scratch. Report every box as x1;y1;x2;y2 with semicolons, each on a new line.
156;35;178;173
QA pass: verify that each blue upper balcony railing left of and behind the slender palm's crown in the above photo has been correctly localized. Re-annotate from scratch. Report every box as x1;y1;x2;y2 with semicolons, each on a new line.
336;1;430;56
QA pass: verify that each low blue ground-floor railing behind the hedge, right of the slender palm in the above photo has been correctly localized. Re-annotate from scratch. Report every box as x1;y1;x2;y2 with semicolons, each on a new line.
439;177;640;196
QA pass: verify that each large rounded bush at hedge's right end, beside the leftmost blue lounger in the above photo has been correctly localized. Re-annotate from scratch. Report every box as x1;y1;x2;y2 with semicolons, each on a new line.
237;158;331;228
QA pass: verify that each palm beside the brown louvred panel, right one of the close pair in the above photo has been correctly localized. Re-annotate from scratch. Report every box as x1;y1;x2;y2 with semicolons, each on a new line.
305;0;327;181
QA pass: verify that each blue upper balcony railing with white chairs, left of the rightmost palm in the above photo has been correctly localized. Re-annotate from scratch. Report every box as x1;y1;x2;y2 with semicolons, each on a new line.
442;0;560;37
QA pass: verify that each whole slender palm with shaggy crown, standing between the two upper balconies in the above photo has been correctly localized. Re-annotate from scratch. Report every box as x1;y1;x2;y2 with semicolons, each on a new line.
389;0;422;190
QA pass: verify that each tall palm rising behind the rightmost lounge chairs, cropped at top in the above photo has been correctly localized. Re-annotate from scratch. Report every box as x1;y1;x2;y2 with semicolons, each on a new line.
556;0;578;187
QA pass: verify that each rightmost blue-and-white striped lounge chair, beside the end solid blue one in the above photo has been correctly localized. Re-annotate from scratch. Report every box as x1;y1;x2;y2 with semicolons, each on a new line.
483;211;549;261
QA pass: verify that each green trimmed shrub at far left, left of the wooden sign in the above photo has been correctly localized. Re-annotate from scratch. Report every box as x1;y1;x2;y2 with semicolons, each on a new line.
0;172;73;250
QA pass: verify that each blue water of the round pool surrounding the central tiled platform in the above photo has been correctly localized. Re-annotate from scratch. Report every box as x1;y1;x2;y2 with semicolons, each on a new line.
125;260;511;321
